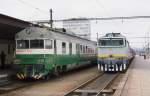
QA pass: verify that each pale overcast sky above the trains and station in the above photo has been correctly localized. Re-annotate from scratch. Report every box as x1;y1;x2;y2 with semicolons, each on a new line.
0;0;150;47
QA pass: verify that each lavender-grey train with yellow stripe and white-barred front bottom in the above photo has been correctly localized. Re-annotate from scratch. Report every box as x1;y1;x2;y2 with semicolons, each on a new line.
97;33;135;72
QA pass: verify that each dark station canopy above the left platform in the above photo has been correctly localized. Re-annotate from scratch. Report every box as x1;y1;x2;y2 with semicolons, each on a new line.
0;14;31;39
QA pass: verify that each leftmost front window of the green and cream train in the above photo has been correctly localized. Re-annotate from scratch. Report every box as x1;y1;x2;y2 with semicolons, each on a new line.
16;40;29;49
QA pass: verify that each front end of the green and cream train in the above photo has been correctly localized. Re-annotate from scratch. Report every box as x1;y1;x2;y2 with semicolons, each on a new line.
14;28;52;80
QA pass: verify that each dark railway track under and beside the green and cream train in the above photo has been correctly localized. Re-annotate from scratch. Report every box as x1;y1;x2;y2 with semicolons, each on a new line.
0;66;98;95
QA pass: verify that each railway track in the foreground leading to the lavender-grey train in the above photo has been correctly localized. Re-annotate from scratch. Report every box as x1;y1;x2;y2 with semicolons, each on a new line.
64;73;119;96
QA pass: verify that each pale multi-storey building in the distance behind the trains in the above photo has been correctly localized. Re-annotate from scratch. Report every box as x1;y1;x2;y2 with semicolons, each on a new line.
63;18;91;40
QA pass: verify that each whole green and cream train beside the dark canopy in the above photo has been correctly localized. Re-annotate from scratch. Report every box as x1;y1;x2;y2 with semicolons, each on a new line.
15;27;96;79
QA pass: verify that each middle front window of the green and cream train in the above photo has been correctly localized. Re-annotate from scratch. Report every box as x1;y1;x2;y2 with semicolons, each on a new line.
30;40;44;49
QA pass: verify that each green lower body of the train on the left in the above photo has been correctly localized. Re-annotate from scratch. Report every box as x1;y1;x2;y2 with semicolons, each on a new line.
15;54;96;79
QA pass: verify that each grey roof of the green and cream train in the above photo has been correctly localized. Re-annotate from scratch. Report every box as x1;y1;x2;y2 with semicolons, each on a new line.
15;27;96;45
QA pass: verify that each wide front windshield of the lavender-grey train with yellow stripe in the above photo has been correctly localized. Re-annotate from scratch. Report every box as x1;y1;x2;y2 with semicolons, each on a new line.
99;38;124;47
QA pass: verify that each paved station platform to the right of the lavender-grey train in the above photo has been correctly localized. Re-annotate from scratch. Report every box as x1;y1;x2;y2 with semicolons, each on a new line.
121;56;150;96
